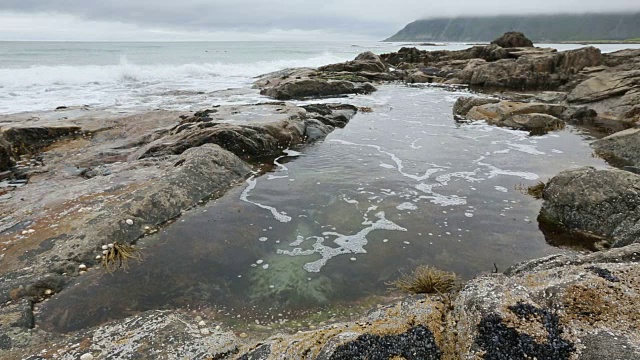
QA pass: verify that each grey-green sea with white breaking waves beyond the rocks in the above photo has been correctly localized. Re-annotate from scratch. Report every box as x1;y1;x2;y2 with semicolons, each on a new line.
0;41;640;114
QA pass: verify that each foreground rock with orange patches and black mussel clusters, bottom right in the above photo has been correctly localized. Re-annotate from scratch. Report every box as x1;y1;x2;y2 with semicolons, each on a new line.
237;245;640;360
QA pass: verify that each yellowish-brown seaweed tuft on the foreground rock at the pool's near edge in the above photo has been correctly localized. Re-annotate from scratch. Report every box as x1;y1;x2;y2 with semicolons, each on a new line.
388;265;457;294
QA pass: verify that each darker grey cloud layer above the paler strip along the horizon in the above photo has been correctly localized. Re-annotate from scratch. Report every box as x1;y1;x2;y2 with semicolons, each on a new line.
0;0;640;36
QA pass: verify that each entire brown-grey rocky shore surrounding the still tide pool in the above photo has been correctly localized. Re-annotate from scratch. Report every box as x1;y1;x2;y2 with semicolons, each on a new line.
0;33;640;360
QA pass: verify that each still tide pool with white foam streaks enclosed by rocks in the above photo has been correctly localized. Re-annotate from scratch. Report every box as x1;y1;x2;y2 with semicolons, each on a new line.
41;86;606;331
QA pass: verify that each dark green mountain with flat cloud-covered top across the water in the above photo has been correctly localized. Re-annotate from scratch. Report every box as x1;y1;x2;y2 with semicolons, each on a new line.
385;12;640;42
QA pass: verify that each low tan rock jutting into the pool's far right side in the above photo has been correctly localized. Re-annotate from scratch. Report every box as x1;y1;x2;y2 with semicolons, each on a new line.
453;97;566;133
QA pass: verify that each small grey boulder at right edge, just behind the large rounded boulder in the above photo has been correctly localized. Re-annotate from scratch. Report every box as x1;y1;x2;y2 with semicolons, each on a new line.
591;129;640;167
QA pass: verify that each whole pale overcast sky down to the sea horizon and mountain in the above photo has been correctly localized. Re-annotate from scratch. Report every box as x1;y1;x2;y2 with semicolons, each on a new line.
0;0;640;41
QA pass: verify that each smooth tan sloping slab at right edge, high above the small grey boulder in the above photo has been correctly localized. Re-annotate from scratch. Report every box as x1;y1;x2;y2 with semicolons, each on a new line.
567;70;640;104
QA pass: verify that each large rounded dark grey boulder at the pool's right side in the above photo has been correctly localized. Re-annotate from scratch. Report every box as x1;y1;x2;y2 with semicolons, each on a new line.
540;168;640;247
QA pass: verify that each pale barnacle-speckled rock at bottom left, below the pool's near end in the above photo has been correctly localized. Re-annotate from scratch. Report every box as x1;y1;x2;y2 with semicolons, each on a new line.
25;311;238;359
